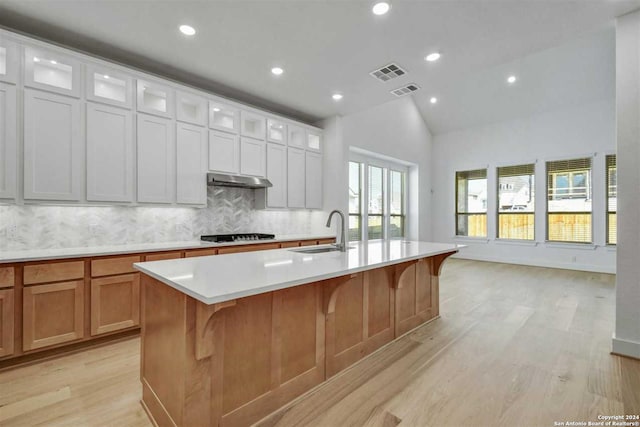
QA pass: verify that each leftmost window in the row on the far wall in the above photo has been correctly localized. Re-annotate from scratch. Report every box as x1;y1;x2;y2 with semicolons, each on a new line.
456;169;487;237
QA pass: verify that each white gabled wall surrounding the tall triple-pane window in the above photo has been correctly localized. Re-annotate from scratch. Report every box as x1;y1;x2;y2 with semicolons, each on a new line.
336;97;431;240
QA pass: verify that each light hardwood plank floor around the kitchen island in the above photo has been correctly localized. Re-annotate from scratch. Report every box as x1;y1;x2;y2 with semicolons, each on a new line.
0;260;640;427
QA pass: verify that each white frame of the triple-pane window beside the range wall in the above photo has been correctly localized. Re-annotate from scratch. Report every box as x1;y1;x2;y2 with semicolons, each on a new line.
348;151;410;243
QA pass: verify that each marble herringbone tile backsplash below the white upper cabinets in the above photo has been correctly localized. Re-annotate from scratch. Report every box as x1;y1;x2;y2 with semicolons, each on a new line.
0;187;333;250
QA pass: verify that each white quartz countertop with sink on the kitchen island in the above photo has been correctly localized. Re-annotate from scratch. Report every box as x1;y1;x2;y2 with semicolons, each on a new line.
134;240;464;304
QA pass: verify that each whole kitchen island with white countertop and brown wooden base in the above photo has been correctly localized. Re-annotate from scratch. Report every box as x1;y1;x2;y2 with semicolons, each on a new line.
135;240;458;426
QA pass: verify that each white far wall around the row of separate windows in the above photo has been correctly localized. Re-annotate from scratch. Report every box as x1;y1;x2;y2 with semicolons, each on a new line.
432;99;616;272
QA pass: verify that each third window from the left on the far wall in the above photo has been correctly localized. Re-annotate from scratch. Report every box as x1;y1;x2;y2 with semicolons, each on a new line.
547;158;592;243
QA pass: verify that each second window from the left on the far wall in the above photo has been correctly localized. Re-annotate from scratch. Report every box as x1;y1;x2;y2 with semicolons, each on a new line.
498;164;535;240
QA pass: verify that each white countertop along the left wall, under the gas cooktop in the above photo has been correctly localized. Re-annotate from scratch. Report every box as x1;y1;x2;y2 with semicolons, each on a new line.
0;234;335;264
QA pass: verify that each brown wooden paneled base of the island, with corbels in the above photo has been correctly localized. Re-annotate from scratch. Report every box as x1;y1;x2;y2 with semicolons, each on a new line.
141;251;457;426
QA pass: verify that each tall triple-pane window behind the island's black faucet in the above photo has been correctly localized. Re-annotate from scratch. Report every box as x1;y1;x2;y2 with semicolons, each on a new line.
349;156;407;241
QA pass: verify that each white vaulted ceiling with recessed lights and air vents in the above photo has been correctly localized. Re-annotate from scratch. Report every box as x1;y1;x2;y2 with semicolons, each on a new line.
0;0;640;133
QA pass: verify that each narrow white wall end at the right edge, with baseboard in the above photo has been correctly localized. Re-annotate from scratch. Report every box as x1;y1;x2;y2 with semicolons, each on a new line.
613;12;640;358
